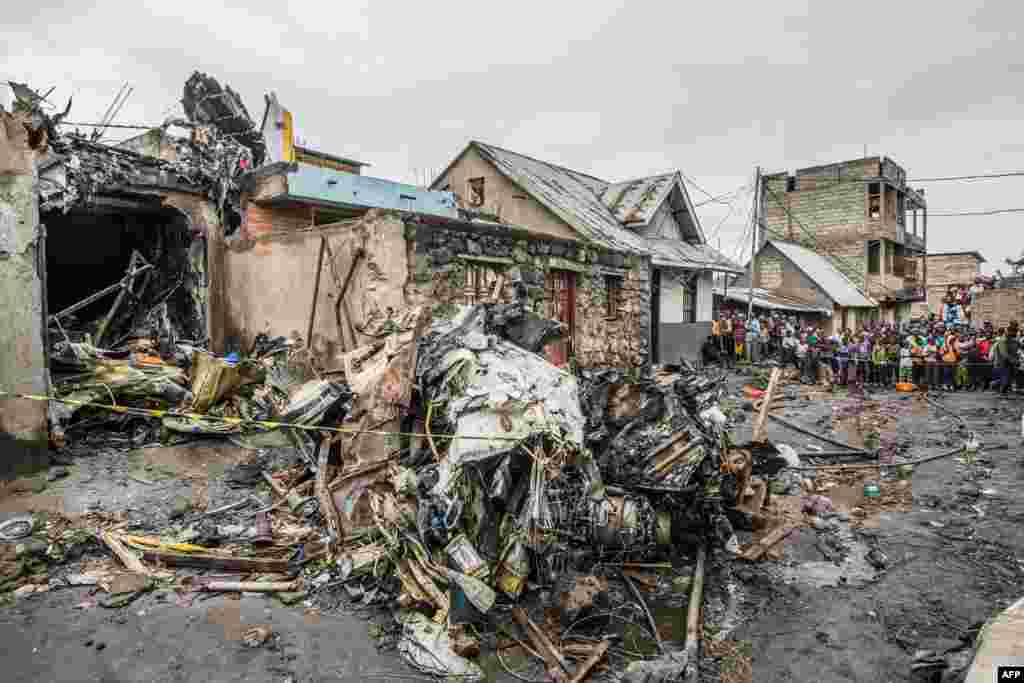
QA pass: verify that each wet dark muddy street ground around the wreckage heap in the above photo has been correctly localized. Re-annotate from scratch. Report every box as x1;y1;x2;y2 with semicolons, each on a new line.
0;376;1024;683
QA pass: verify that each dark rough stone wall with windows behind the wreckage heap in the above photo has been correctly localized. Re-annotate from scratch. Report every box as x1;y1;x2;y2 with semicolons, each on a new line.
407;219;650;368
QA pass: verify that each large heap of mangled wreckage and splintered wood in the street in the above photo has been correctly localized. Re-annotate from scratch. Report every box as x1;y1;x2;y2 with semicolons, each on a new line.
22;292;782;680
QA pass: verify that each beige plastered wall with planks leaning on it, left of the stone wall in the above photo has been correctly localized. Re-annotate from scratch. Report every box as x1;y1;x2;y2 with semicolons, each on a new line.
217;211;411;368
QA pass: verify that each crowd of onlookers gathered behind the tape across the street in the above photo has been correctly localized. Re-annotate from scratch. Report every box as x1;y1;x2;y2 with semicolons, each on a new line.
702;311;1024;394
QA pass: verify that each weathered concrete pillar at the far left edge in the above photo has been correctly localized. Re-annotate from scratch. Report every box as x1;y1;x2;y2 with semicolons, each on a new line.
0;147;49;446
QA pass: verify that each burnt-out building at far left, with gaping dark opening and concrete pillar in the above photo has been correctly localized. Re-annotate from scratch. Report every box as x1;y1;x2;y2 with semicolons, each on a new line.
0;74;264;454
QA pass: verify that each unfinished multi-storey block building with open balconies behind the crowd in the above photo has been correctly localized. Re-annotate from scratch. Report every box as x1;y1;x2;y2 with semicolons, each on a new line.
762;157;928;321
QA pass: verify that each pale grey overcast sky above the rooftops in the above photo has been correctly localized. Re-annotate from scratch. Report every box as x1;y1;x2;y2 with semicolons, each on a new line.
0;0;1024;271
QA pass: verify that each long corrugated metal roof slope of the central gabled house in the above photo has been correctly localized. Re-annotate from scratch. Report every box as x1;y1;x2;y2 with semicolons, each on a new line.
473;141;649;255
